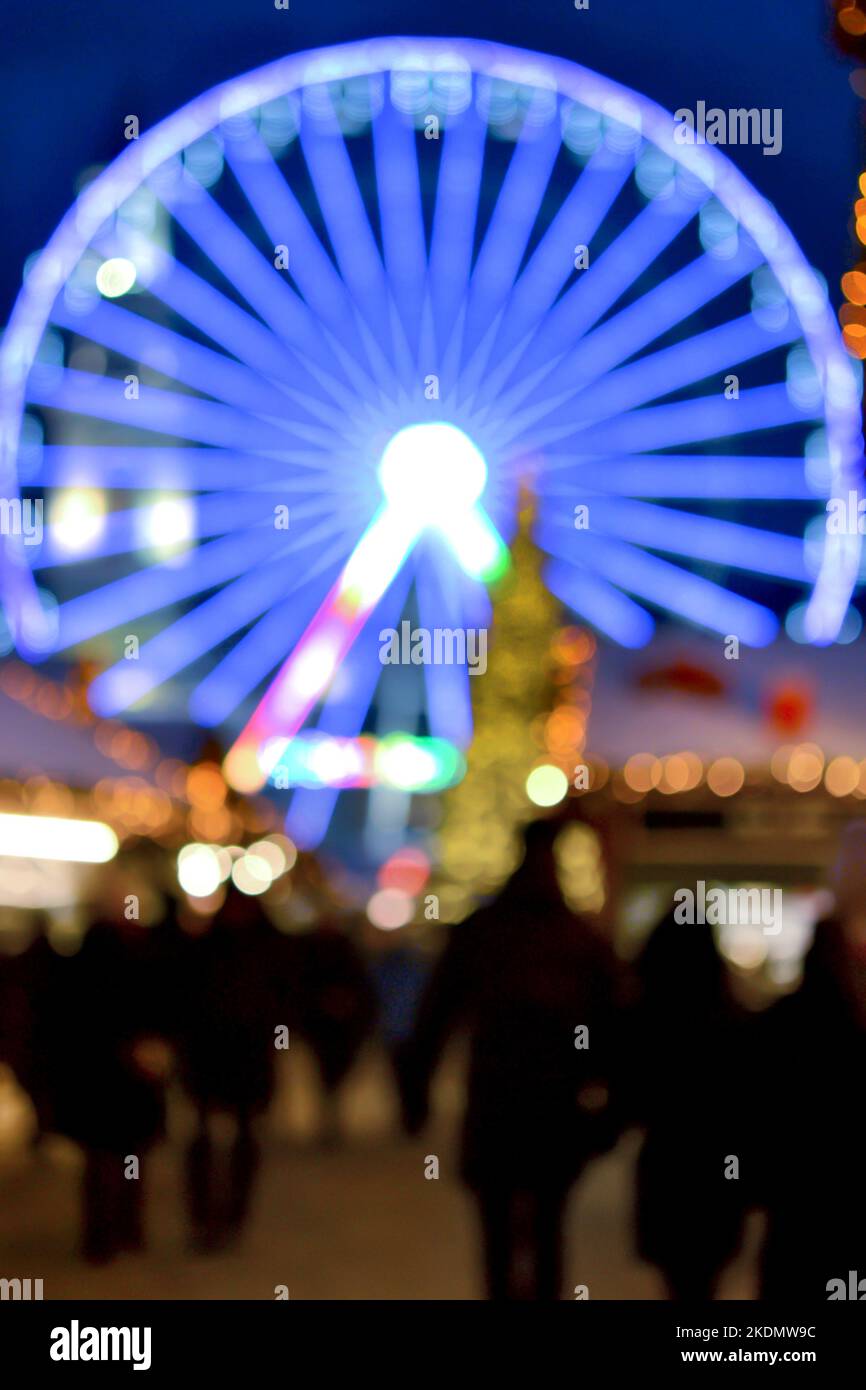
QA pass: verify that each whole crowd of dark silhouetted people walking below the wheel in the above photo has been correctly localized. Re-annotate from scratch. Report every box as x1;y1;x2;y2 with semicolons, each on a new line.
0;821;866;1301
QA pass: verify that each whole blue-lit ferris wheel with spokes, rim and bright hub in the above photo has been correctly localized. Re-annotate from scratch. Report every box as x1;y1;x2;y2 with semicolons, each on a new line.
0;39;862;822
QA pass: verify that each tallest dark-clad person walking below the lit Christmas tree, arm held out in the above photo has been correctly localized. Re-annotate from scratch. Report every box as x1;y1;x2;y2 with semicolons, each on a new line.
402;821;616;1300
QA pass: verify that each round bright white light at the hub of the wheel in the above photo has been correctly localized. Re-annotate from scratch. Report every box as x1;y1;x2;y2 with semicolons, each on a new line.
379;421;487;525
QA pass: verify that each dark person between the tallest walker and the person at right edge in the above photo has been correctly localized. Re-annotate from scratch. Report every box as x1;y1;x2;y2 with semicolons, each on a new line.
627;913;749;1301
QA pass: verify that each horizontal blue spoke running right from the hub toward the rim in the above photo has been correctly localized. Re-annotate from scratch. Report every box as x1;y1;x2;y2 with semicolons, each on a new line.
537;453;815;502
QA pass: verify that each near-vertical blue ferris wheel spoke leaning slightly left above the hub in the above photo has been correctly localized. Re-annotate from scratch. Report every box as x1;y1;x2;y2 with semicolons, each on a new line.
373;101;427;361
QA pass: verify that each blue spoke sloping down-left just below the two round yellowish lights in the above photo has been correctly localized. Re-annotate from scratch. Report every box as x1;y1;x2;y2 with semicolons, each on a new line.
56;531;291;652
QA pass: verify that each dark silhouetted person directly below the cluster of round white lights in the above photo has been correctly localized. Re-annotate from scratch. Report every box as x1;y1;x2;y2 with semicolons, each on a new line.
179;888;288;1252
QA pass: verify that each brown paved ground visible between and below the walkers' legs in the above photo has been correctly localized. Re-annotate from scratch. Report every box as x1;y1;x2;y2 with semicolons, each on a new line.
0;1048;755;1300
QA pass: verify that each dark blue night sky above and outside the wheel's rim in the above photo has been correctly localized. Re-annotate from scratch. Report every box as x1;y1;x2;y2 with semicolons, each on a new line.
0;0;862;322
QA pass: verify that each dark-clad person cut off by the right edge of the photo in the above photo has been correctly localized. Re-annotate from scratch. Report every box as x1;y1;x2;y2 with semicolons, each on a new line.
752;821;866;1301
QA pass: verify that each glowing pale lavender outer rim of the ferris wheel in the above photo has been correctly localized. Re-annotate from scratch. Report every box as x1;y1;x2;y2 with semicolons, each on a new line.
0;36;862;644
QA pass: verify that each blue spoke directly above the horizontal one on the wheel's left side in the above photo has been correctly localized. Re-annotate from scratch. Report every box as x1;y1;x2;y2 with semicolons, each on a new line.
28;367;339;452
